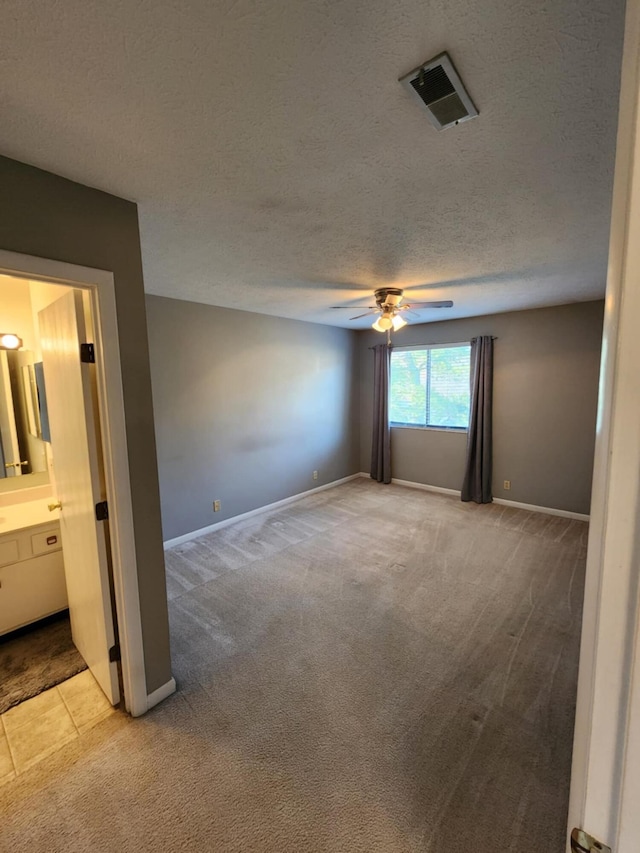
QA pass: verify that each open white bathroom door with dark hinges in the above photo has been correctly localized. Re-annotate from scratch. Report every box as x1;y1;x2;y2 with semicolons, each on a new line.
38;290;119;705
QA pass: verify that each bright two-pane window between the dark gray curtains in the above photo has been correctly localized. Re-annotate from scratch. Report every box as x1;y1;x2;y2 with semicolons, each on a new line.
389;344;471;429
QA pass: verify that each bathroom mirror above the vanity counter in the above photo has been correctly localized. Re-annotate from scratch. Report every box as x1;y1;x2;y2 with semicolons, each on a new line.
0;350;49;491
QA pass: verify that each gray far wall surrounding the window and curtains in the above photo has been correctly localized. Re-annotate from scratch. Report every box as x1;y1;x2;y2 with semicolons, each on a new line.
359;302;604;513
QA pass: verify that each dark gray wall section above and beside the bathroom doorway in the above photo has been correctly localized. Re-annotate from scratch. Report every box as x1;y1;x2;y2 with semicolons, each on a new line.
0;157;171;692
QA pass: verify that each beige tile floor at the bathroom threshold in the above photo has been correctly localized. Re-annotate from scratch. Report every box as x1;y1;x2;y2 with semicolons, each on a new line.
0;669;115;785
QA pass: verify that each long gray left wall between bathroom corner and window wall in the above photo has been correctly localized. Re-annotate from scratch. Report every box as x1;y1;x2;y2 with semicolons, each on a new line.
147;296;359;539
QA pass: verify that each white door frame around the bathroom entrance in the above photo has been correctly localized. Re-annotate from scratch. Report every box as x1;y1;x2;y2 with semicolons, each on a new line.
0;249;149;717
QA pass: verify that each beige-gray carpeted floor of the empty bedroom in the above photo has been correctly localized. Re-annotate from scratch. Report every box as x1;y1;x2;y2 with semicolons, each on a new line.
0;480;587;853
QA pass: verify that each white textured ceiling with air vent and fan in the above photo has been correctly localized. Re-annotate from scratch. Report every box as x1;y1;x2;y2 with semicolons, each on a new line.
0;0;624;328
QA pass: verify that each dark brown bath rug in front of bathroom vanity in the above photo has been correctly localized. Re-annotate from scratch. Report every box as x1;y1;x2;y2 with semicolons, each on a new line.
0;611;87;714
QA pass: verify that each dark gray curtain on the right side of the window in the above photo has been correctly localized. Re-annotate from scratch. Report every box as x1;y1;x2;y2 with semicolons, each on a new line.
462;335;493;504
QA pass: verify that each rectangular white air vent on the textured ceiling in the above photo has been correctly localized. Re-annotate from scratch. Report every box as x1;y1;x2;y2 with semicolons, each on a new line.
399;53;478;130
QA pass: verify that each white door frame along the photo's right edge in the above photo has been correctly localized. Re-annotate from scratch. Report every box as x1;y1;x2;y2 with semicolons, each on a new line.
567;0;640;853
